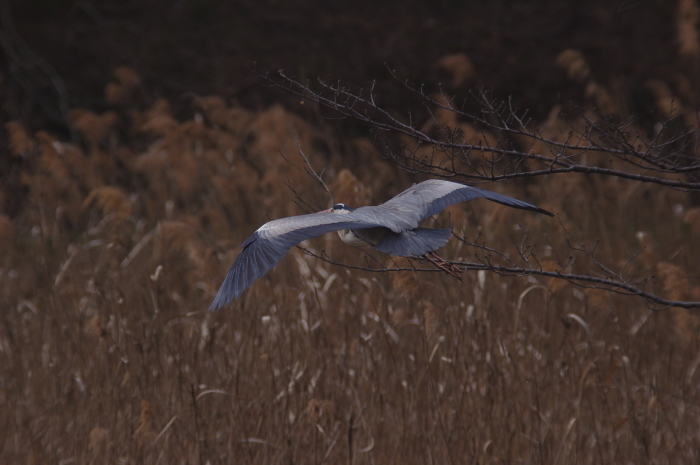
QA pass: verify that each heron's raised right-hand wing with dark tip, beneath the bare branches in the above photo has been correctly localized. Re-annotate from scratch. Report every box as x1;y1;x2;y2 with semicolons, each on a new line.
353;179;554;232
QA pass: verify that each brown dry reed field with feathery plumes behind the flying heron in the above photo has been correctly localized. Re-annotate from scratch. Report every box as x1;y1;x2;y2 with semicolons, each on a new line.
0;62;700;464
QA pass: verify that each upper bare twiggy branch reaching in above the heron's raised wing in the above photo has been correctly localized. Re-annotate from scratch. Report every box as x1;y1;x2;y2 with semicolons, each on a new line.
258;66;700;191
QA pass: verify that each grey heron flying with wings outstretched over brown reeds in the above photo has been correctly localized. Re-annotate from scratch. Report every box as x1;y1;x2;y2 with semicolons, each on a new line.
209;179;554;311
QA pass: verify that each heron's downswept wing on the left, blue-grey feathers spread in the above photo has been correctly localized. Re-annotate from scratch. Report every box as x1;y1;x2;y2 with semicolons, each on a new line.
209;212;379;310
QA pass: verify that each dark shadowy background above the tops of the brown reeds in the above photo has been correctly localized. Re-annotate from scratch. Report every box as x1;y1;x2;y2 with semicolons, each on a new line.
4;0;683;123
